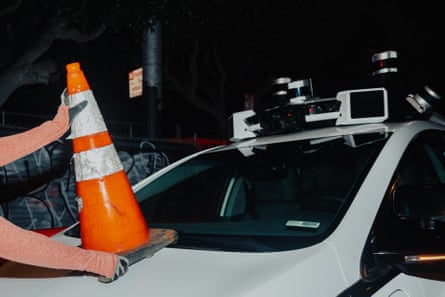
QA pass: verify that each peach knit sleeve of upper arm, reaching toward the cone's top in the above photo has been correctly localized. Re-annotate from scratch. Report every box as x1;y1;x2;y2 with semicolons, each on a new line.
0;105;70;166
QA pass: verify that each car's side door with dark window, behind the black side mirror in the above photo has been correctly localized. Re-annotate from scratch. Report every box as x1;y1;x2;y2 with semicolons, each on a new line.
356;131;445;297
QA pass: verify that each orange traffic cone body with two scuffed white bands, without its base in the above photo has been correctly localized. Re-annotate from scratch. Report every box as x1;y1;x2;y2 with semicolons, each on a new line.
66;62;150;253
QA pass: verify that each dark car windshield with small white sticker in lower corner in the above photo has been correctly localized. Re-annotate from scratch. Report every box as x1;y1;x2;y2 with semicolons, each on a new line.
136;133;388;251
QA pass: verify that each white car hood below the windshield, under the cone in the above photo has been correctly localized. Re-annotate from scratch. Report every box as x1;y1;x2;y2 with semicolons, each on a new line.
0;243;345;297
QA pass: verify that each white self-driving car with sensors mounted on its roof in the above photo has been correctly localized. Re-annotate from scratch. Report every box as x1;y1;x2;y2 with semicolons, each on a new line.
0;84;445;297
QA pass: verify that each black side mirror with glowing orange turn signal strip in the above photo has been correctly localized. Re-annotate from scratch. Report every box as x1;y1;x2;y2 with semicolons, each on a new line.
373;184;445;280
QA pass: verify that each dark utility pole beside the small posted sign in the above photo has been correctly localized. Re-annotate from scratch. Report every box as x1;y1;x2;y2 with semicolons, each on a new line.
142;19;163;139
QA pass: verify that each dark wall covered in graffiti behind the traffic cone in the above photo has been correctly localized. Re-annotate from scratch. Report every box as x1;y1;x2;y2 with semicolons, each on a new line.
0;139;194;229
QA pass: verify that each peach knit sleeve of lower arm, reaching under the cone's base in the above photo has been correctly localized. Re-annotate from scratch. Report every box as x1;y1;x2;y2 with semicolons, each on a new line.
0;216;117;277
